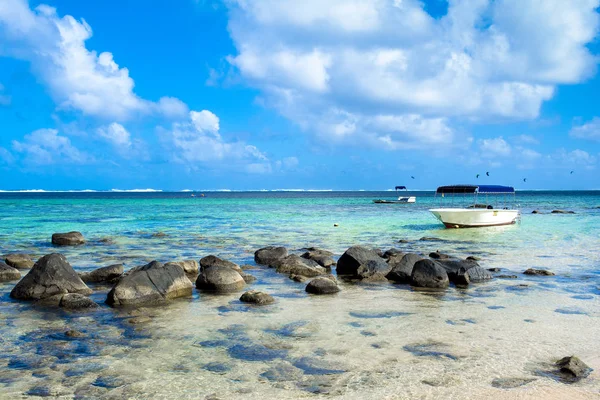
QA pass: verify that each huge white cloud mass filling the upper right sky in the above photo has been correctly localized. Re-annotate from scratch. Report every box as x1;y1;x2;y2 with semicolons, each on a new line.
227;0;599;151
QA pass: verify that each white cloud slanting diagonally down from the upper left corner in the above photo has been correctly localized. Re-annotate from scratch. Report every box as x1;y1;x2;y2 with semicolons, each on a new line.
0;0;187;121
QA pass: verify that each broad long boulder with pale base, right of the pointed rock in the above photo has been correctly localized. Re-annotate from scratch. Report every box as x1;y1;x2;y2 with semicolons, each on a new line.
106;261;193;307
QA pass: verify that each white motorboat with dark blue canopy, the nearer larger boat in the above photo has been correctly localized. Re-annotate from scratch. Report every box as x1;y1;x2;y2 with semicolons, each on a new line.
429;185;521;228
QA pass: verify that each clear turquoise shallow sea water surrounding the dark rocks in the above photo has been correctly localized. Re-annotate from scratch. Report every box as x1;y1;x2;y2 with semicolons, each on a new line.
0;192;600;399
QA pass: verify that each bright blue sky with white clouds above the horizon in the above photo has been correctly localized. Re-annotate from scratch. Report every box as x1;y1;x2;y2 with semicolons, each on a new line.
0;0;600;190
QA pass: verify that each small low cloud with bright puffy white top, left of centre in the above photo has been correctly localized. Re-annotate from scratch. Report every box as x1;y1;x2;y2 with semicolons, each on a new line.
159;110;270;167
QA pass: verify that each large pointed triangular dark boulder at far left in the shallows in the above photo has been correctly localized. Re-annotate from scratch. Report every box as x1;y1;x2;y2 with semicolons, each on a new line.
10;253;92;300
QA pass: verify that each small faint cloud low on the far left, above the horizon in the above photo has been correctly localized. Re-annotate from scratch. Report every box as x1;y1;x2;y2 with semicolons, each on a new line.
12;129;92;165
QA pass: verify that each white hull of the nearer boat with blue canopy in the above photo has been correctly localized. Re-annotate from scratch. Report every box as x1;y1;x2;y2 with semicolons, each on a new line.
429;208;519;228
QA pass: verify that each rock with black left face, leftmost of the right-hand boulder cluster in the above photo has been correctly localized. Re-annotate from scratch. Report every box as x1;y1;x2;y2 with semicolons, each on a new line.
336;246;392;281
